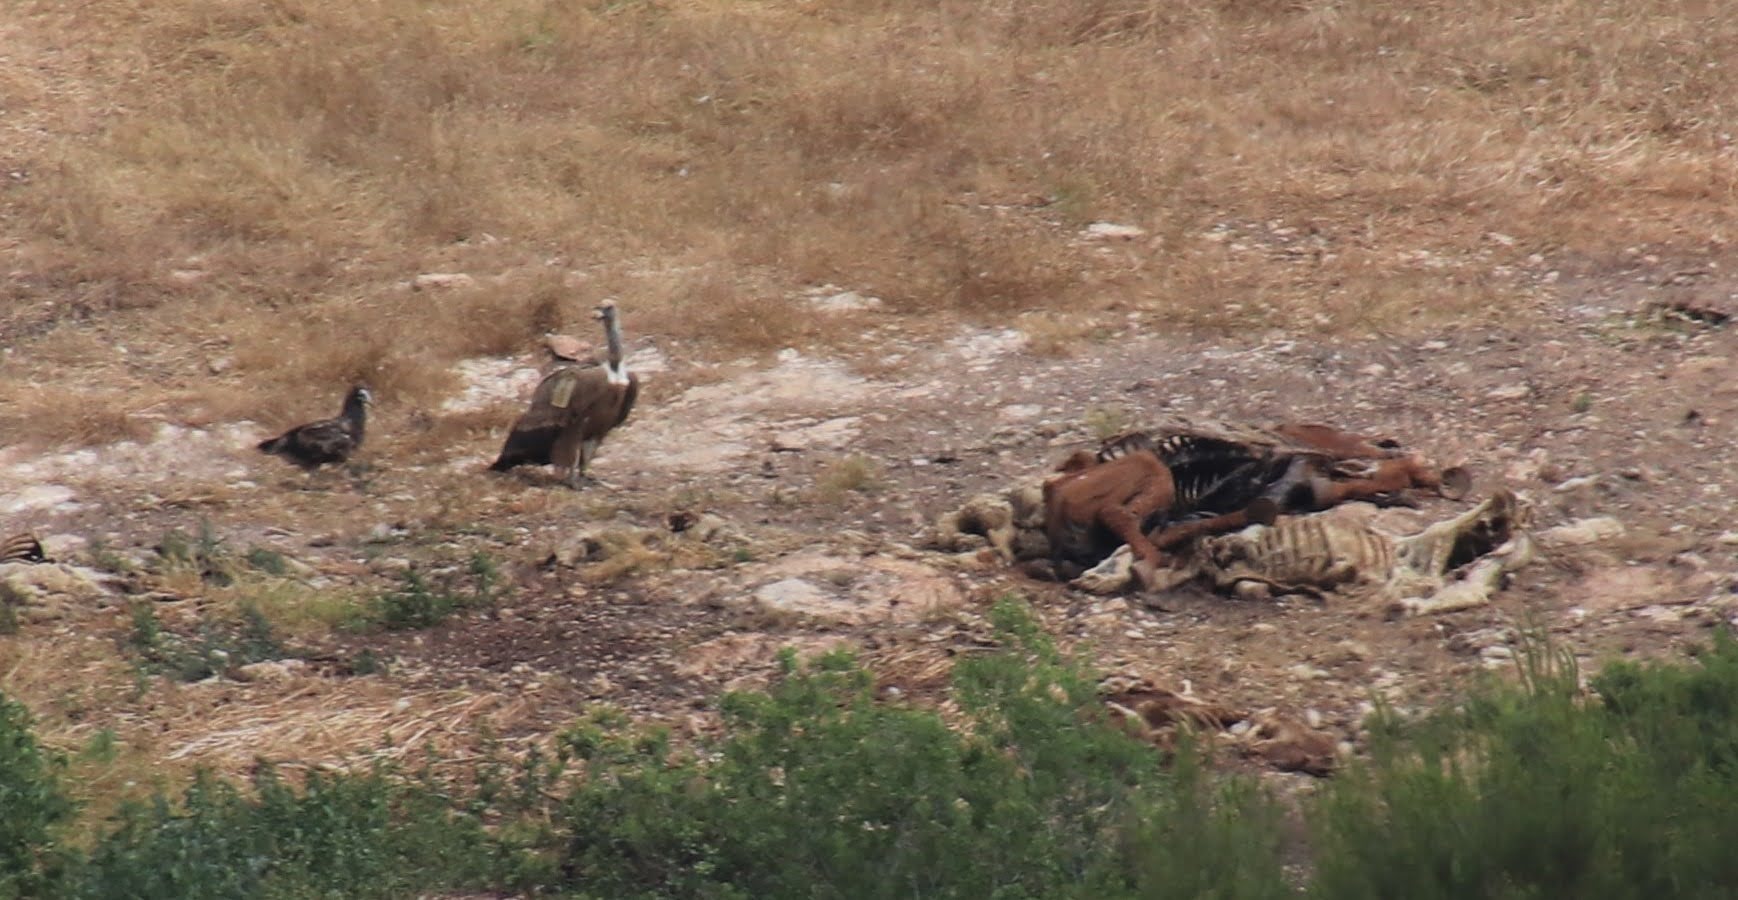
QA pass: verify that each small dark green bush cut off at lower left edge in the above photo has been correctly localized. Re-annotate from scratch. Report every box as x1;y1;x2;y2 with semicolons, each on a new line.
0;693;73;897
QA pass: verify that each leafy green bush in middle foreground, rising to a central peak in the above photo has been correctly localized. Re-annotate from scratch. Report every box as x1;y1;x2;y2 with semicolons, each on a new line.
556;606;1283;898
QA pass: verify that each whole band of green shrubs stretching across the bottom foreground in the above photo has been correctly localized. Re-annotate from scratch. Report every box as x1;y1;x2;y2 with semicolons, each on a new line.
16;603;1738;898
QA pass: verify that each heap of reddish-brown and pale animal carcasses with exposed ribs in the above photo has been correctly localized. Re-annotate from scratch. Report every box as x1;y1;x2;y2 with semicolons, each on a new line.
930;422;1533;615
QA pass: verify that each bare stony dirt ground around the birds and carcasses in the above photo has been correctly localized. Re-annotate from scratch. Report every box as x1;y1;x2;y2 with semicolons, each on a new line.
0;243;1738;785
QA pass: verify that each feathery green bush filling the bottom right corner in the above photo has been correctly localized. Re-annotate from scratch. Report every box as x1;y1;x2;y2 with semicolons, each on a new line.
1314;636;1738;900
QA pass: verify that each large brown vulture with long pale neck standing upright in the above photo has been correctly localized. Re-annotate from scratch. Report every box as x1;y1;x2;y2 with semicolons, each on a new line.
490;301;640;488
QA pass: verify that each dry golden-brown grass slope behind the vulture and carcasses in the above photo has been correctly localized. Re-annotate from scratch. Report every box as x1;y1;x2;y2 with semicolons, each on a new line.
0;0;1738;443
